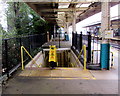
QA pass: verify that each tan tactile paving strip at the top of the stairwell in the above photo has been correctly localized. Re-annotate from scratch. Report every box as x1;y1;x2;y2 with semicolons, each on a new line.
19;68;96;80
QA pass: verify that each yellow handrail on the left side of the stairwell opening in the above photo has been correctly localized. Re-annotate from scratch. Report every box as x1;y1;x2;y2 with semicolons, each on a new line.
21;46;40;70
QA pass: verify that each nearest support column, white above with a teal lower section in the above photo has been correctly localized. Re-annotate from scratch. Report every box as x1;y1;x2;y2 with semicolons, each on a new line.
100;2;110;70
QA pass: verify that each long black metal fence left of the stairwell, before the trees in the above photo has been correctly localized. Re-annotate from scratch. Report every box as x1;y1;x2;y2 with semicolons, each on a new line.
2;33;47;76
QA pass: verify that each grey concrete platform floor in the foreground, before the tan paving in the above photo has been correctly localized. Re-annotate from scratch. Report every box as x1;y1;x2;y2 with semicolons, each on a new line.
3;68;118;94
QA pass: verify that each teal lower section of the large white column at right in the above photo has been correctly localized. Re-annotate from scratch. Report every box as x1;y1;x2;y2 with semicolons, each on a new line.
100;43;110;70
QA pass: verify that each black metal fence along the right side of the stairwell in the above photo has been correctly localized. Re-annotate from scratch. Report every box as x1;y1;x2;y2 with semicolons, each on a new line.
72;32;91;63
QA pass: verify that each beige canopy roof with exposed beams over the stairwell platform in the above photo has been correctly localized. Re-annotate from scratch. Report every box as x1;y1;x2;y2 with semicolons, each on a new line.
25;0;116;26
